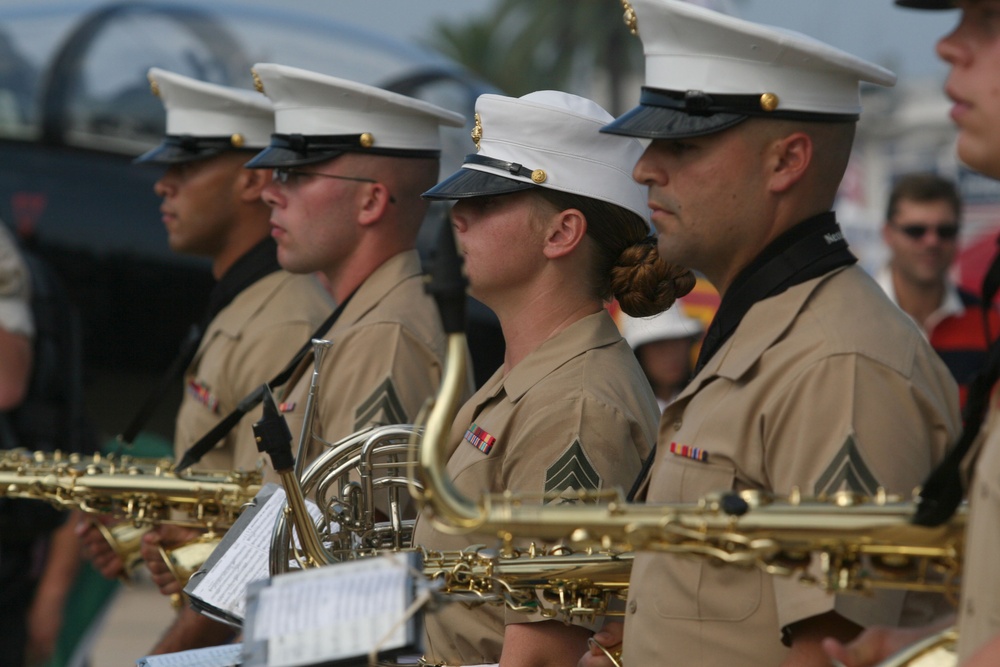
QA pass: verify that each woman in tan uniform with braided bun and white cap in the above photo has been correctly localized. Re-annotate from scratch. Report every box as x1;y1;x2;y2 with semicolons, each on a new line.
414;91;694;665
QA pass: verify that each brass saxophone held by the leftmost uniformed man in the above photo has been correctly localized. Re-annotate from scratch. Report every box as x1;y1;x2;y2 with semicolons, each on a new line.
0;449;261;582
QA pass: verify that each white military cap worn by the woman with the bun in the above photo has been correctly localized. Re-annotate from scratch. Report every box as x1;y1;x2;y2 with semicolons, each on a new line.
423;90;649;220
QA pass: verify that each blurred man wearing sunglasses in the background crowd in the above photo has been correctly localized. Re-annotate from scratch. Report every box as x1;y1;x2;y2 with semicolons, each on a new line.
877;173;1000;405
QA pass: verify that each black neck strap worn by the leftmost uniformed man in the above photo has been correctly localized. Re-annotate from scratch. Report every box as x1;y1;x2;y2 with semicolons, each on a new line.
117;237;281;445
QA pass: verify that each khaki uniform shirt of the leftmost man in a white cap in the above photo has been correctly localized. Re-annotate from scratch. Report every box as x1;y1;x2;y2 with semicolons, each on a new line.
174;271;333;470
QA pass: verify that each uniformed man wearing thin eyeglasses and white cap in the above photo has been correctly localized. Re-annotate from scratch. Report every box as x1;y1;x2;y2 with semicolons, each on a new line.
247;63;463;474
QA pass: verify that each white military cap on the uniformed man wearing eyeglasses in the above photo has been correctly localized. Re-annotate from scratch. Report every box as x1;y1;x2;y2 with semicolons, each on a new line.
247;63;465;168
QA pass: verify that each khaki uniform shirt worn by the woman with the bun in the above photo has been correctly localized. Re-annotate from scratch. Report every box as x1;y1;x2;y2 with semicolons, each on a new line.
413;311;659;665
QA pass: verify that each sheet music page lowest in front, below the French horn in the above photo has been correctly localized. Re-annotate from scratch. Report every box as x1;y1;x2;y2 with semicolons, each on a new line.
247;554;414;667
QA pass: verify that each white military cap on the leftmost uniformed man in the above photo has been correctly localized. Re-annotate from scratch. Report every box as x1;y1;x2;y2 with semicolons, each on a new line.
135;67;274;164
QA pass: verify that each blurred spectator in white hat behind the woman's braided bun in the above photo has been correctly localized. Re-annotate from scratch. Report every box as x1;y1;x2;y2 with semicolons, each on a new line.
621;301;702;412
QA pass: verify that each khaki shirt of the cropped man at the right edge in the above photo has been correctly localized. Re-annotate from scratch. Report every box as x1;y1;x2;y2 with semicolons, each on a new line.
958;396;1000;664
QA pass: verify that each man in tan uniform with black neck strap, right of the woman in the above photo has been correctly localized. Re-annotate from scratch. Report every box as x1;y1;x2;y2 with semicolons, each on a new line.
582;0;959;667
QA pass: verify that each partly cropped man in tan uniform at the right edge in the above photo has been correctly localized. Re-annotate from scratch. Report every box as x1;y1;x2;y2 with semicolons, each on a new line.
824;0;1000;667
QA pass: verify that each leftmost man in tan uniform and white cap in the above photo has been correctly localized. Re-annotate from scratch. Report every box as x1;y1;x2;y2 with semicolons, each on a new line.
83;68;333;653
